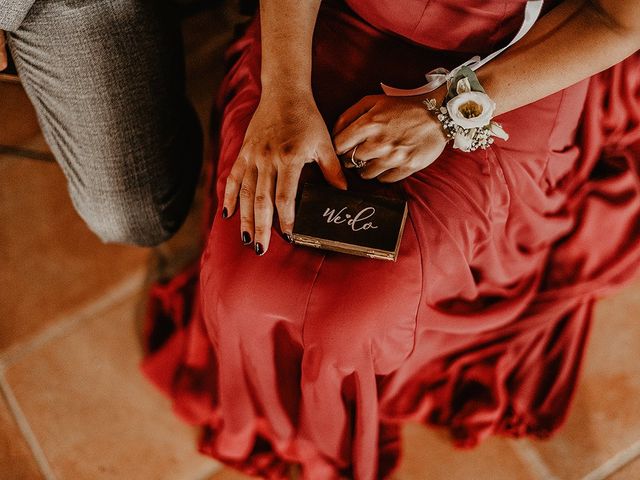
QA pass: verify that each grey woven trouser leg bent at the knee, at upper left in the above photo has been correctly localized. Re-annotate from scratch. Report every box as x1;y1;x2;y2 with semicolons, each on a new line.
9;0;202;245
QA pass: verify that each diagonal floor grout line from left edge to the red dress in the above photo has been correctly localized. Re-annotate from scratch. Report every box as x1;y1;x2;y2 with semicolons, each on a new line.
0;267;147;368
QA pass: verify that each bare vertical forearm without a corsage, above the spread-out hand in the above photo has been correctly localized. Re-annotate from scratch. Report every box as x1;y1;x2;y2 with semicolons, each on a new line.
260;0;321;94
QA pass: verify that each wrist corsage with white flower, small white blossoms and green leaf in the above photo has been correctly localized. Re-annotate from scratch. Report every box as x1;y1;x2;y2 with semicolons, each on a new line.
422;66;509;152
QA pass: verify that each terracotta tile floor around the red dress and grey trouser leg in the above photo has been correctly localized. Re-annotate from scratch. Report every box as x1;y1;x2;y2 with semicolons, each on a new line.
0;1;640;480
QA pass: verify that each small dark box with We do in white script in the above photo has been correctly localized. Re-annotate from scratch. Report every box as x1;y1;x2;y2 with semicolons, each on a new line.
292;183;407;261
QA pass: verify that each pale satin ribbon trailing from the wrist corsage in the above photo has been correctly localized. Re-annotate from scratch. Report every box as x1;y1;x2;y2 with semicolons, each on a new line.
380;0;544;97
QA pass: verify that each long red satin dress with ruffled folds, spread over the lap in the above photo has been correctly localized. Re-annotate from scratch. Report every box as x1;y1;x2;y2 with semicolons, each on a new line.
142;0;640;480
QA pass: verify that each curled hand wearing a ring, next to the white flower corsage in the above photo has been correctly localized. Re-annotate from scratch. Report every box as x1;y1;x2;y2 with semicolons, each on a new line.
333;92;447;182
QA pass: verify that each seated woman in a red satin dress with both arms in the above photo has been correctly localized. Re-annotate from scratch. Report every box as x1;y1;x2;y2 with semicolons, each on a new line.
143;0;640;480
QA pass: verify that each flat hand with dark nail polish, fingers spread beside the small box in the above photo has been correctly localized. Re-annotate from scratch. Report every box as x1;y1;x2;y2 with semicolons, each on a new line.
222;91;347;255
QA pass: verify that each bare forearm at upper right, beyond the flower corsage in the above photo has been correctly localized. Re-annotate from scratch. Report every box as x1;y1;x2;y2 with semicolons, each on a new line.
477;0;640;115
